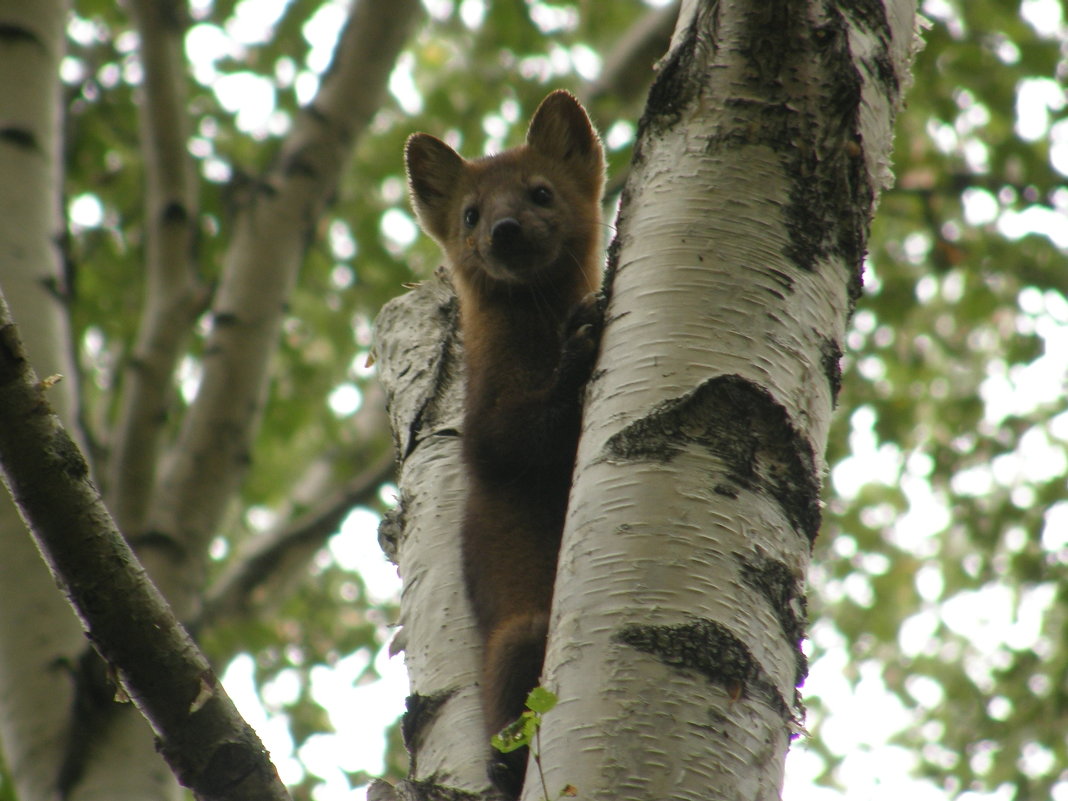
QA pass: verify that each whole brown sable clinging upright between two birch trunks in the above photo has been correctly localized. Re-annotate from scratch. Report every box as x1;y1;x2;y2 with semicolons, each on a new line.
406;92;604;794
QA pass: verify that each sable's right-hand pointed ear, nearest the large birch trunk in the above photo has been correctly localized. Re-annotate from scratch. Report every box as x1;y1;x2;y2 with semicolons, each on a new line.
527;89;604;194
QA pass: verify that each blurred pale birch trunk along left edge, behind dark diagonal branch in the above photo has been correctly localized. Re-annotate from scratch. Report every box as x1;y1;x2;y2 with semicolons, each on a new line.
0;0;84;801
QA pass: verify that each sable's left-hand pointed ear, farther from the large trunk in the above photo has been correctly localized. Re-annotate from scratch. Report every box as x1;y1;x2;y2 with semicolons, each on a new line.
404;134;467;242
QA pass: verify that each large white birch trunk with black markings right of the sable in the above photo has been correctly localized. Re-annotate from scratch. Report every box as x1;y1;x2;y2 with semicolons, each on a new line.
538;0;914;801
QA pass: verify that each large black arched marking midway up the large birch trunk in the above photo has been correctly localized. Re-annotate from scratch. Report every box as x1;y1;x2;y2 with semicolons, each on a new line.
602;375;820;543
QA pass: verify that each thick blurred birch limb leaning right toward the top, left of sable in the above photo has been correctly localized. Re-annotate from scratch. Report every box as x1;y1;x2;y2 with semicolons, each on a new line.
147;0;421;611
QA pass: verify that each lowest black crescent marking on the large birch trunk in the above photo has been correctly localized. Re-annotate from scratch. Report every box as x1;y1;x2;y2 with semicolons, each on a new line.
612;618;794;720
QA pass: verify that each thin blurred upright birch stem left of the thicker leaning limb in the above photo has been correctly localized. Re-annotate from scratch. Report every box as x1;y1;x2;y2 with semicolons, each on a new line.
108;0;208;535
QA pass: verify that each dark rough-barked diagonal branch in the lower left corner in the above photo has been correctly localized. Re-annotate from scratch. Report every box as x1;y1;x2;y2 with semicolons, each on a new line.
0;297;289;801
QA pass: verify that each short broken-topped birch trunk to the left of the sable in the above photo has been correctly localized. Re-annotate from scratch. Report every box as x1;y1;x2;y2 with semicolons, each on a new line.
375;272;489;798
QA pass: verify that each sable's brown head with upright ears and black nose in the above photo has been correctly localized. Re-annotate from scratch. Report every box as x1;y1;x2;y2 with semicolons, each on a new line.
405;91;604;290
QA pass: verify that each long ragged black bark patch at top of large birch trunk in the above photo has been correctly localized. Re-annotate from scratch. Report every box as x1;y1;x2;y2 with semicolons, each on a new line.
692;0;875;302
